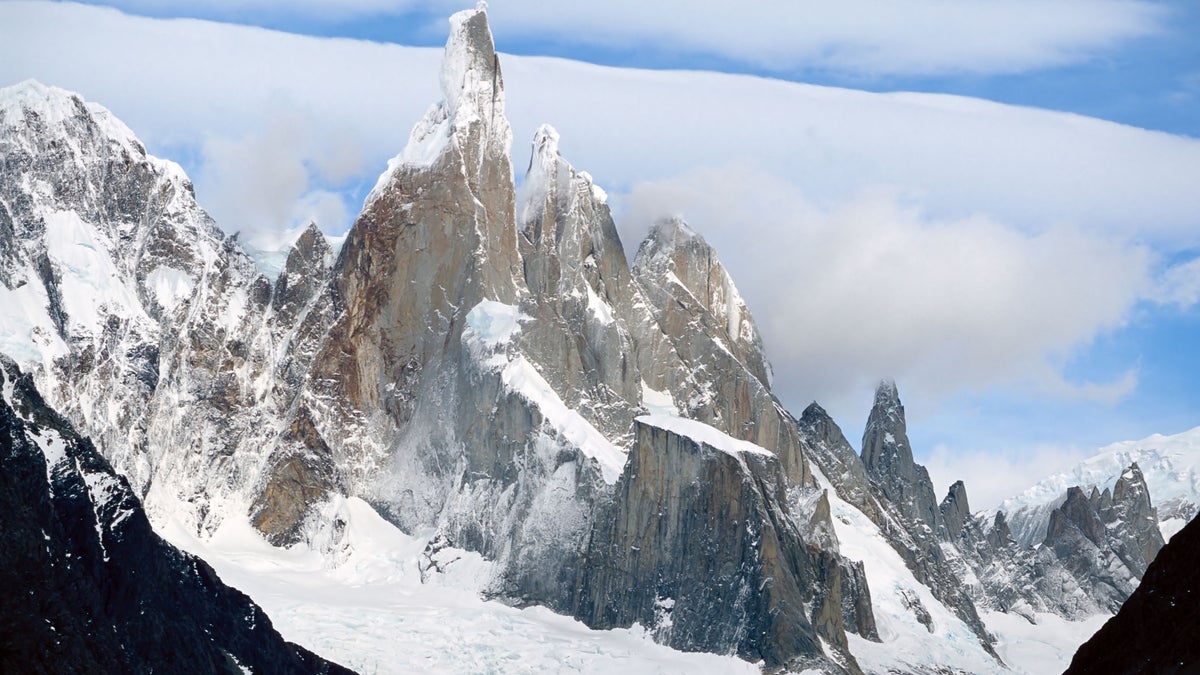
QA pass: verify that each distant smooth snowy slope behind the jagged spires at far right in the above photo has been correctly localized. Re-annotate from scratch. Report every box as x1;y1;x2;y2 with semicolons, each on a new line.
1000;426;1200;545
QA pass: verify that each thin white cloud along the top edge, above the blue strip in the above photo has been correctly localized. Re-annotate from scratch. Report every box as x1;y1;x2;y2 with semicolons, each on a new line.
75;0;1168;76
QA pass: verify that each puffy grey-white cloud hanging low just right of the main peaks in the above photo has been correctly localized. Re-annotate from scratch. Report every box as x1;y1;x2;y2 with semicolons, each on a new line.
622;166;1152;417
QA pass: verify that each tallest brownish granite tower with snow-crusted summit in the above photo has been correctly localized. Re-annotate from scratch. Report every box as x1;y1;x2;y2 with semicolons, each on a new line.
291;5;521;527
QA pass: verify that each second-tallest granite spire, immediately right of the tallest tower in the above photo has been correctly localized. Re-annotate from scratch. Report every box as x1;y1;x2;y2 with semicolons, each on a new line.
517;125;652;438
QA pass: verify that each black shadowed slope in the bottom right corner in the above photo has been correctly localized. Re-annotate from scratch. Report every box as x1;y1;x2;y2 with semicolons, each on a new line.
1067;511;1200;675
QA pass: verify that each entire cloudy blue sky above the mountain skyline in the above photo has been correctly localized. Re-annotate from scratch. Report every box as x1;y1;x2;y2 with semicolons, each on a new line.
0;0;1200;506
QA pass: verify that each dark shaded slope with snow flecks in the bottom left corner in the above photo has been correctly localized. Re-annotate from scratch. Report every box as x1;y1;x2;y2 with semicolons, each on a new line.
0;357;350;674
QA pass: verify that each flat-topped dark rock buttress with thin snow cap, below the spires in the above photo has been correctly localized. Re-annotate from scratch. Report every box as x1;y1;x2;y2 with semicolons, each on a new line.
575;417;871;671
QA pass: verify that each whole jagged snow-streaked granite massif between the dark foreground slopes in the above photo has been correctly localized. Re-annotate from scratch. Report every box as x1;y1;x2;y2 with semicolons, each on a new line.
0;10;1195;673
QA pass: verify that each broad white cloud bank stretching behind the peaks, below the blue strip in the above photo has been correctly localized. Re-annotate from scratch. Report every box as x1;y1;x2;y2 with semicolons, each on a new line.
0;1;1200;468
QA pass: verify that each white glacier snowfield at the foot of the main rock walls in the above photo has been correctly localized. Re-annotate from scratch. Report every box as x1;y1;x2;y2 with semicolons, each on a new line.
160;497;758;675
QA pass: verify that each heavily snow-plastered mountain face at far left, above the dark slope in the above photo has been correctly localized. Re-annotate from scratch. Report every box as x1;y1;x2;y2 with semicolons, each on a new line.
0;76;324;531
